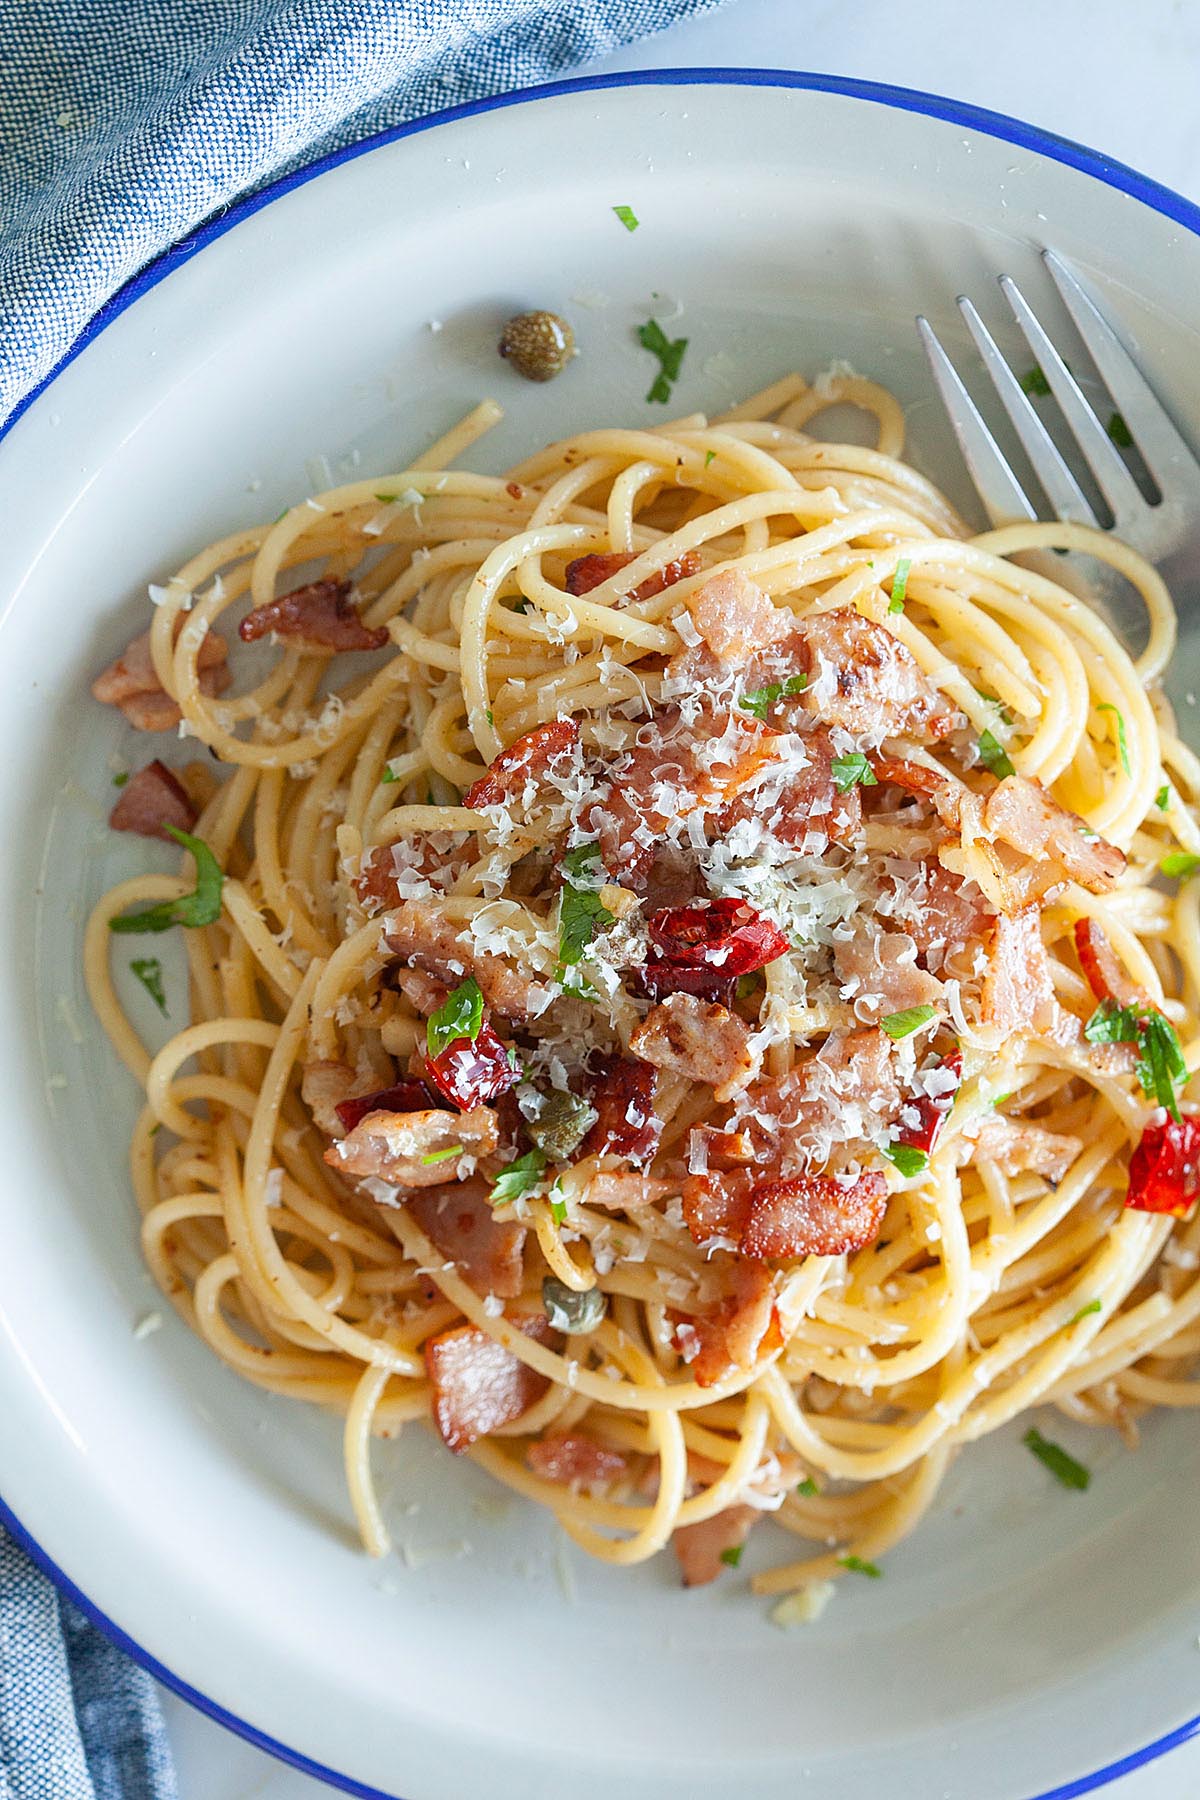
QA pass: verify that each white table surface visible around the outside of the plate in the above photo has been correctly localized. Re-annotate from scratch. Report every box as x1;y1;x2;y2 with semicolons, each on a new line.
164;0;1200;1800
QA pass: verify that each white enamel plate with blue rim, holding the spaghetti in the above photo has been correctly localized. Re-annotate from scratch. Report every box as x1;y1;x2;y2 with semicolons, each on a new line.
0;70;1200;1800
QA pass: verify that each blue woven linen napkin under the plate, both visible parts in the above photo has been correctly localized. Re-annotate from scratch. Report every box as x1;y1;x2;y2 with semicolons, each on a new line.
0;0;721;1800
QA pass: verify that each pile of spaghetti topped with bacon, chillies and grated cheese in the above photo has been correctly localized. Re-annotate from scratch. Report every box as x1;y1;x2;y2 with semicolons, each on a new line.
86;376;1200;1618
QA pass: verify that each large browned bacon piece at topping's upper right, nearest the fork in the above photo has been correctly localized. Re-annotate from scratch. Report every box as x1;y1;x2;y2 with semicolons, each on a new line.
779;607;966;742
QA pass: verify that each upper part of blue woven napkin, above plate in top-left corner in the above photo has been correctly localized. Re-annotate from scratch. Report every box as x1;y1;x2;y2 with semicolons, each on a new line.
0;0;721;424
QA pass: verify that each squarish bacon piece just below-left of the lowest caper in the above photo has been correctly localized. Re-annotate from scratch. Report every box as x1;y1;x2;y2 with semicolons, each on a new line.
425;1314;552;1451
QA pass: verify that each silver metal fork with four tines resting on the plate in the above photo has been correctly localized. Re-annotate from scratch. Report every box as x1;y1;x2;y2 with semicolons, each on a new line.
916;250;1200;612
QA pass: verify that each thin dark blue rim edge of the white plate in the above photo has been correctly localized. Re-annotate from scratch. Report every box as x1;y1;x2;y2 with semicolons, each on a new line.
0;68;1200;1800
